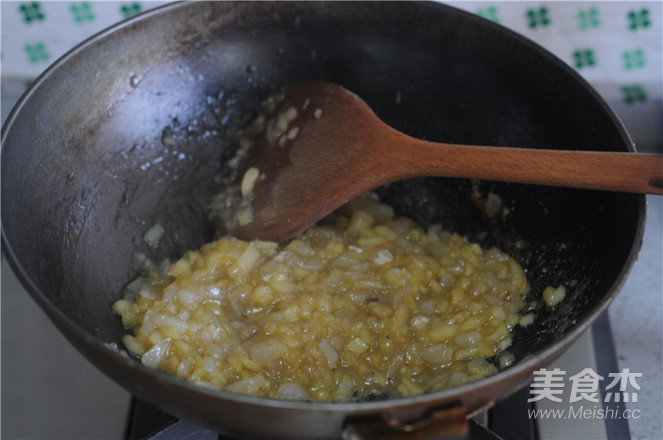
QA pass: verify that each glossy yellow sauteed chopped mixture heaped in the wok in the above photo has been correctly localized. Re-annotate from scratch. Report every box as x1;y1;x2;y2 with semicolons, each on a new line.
113;194;532;401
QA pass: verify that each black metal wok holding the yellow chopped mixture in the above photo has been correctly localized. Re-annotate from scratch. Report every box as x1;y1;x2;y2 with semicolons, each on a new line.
2;2;645;438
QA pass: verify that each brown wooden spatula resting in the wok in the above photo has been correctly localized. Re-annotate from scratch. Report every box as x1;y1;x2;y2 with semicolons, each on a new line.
219;81;663;241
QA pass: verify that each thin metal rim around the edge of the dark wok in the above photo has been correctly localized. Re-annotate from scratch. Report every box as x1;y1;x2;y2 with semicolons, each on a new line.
0;2;648;416
